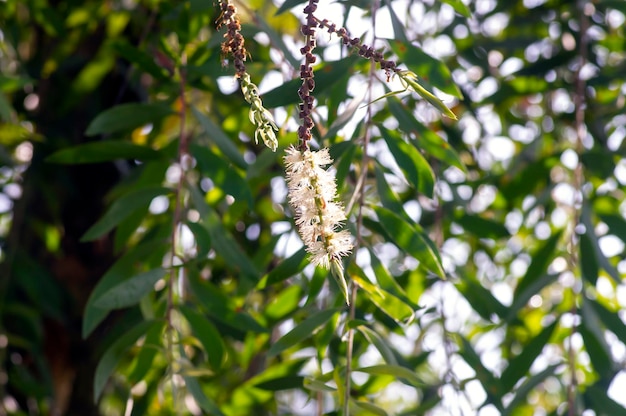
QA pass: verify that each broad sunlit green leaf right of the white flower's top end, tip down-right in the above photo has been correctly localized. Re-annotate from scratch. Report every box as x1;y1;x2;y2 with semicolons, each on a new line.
378;126;435;198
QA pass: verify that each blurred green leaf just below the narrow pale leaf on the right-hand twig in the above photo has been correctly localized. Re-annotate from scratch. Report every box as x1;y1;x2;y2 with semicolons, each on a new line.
387;97;467;172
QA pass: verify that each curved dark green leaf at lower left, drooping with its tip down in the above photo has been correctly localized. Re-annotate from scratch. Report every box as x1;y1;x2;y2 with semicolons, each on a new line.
93;321;157;403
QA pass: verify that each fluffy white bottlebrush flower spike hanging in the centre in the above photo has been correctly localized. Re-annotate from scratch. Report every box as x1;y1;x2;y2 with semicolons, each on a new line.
285;146;353;303
